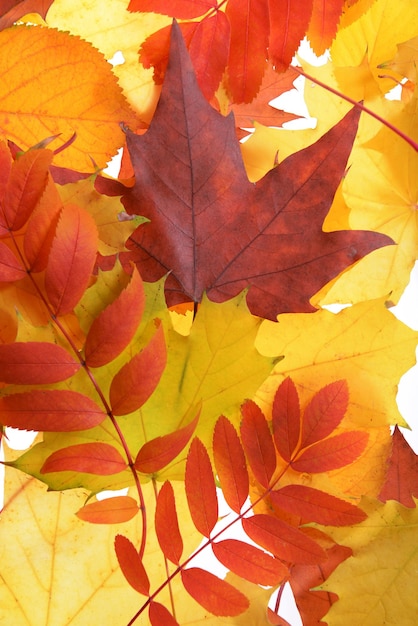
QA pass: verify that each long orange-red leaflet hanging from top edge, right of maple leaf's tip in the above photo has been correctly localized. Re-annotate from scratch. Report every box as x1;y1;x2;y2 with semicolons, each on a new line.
225;0;270;103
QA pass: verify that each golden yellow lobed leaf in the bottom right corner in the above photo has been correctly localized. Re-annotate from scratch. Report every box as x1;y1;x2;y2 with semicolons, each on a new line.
320;500;418;626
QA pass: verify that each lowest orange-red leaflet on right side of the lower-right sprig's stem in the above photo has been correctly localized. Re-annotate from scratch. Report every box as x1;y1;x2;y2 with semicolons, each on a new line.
181;567;250;617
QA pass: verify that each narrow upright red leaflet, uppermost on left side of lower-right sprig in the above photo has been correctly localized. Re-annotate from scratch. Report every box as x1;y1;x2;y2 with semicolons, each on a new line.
272;378;300;462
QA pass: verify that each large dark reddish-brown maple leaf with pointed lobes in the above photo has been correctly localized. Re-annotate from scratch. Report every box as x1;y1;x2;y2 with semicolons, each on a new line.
122;25;391;319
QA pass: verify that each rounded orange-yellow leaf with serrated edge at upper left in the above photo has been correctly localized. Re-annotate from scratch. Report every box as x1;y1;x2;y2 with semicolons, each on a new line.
0;25;137;172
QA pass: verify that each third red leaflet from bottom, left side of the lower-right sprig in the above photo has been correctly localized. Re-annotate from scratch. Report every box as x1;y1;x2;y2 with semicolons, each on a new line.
185;437;218;537
